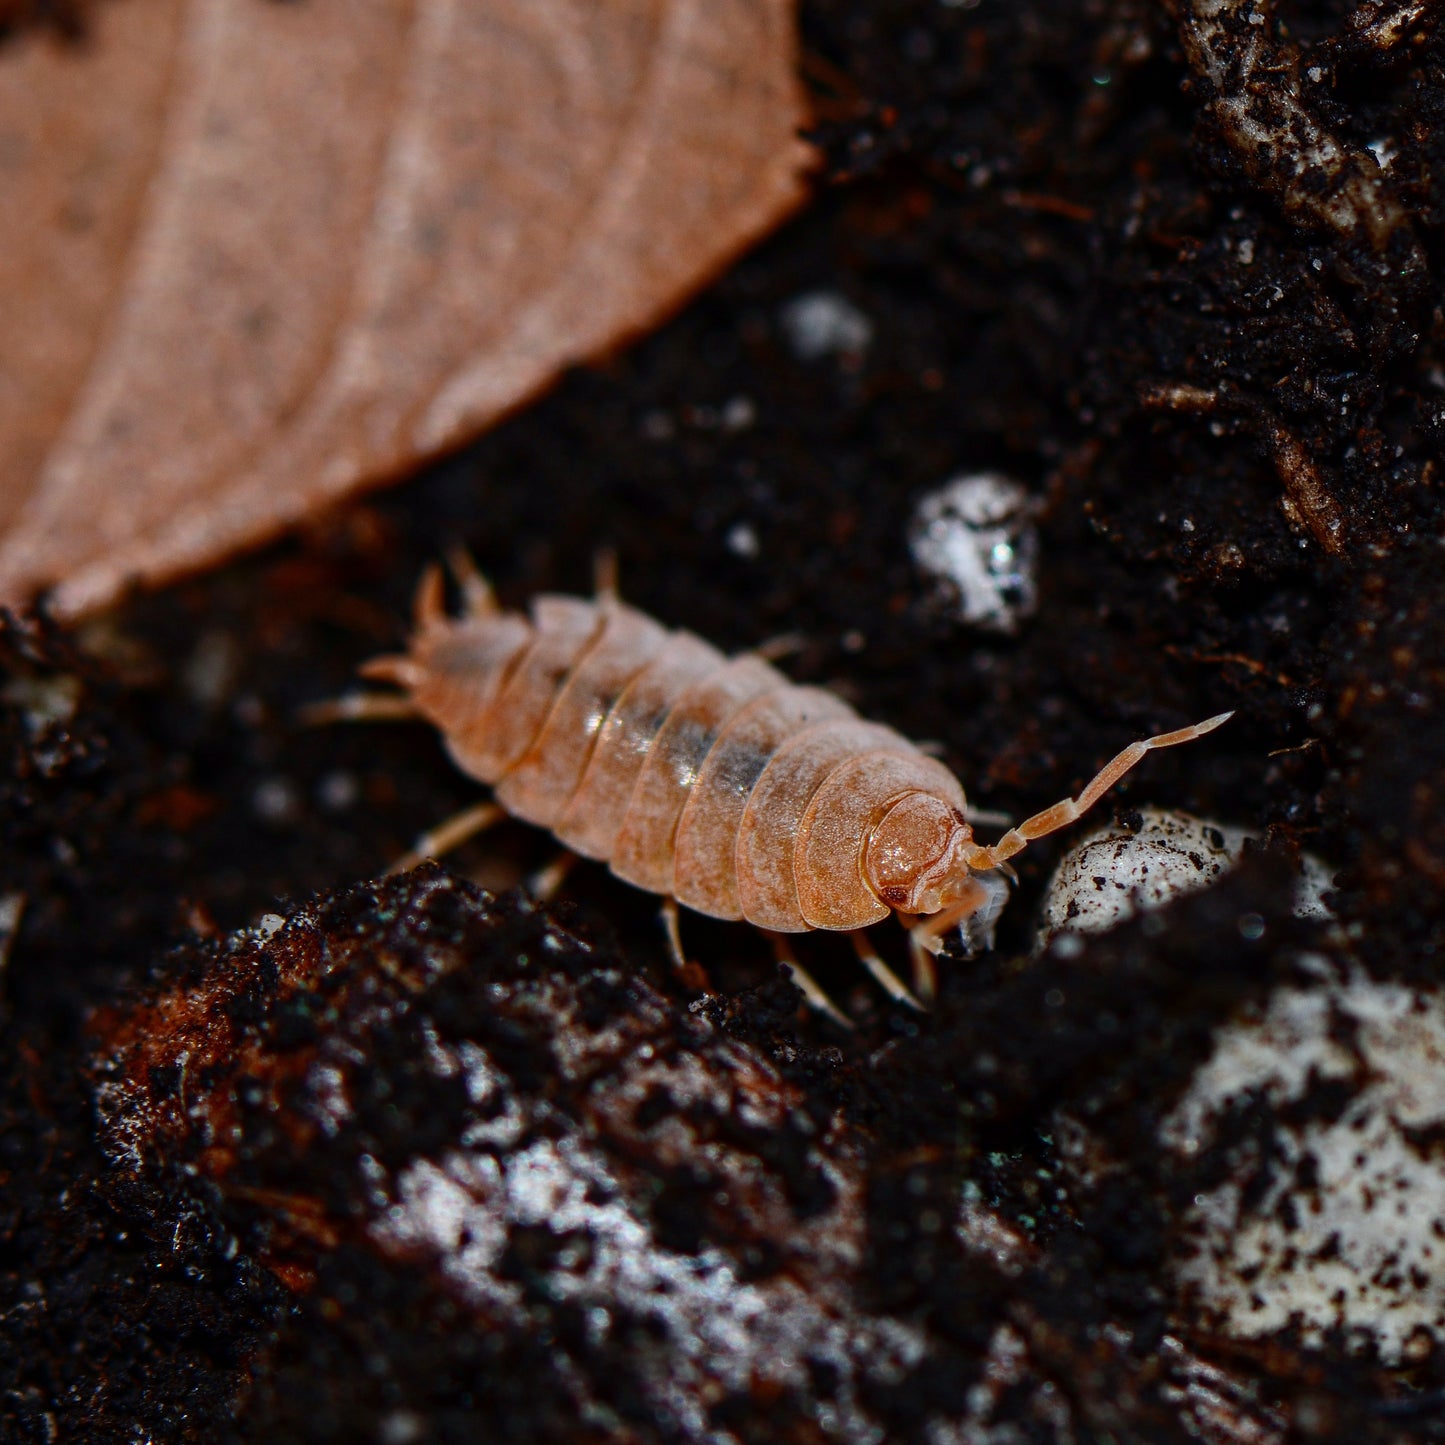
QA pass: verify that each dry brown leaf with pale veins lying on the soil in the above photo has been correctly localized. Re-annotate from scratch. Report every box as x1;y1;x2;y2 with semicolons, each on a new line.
0;0;809;616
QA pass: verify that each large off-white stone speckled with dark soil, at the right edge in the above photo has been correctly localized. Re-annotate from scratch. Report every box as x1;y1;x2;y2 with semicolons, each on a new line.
1162;959;1445;1364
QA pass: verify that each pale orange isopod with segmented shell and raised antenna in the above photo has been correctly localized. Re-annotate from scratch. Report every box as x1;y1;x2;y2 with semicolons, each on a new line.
341;561;1233;1013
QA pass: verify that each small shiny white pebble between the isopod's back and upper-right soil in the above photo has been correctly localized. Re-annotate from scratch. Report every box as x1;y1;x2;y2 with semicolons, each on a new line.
909;471;1039;633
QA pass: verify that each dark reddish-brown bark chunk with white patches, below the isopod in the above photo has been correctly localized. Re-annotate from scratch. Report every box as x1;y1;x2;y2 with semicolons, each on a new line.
91;864;1283;1445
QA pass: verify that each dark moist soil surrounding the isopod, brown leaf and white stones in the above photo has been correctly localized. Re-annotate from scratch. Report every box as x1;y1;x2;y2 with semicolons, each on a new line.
0;0;1445;1445
